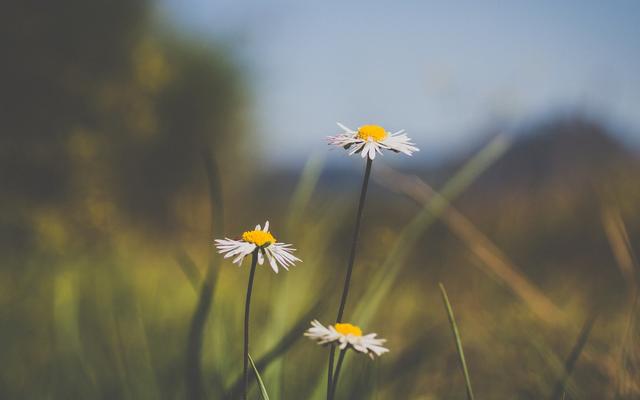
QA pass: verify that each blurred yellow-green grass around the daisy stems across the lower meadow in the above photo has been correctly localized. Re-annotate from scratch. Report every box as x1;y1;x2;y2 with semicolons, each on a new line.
0;130;637;399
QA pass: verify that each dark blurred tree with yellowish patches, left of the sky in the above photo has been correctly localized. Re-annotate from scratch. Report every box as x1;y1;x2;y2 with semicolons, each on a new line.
0;0;242;248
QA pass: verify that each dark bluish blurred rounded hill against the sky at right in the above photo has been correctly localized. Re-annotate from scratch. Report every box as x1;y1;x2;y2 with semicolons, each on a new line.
464;116;638;198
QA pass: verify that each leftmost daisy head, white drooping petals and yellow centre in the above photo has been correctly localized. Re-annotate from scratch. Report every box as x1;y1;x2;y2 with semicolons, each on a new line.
215;221;302;274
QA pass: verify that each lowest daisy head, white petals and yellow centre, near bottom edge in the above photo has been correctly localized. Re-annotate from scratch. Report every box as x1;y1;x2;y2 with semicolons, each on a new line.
304;319;389;359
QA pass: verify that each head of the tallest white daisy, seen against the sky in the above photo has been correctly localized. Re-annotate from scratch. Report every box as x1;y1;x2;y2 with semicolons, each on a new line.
327;122;420;160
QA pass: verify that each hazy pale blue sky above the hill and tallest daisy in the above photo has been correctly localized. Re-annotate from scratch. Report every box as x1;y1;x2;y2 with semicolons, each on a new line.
158;0;640;164
